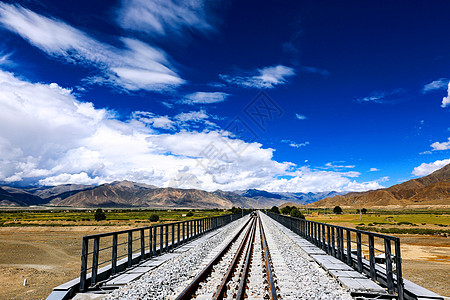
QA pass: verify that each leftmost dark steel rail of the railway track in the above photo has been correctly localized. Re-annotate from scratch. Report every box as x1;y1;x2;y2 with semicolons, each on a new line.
176;218;253;300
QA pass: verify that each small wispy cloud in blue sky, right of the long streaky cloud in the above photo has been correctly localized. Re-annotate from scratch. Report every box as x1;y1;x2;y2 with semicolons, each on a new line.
219;65;295;89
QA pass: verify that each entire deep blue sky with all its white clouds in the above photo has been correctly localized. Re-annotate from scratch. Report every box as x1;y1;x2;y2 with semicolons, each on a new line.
0;0;450;192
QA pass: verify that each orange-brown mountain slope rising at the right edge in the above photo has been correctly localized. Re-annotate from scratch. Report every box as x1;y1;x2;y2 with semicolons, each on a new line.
311;164;450;208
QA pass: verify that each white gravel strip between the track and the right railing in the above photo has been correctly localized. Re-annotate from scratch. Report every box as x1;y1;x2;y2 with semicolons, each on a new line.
260;213;353;300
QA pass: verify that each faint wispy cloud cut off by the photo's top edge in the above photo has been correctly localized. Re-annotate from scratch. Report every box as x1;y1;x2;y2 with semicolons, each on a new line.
118;0;214;35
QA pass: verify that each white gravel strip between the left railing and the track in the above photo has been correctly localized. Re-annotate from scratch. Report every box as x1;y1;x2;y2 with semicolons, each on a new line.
107;216;248;300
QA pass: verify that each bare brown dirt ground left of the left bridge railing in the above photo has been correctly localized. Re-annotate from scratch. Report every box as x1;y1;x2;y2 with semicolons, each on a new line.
0;226;134;299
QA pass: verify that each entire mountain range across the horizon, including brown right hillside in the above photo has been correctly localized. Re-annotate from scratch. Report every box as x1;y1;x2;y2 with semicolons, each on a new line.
0;164;450;208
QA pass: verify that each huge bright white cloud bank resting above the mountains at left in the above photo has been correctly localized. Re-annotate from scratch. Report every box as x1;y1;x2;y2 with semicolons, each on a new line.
0;70;386;192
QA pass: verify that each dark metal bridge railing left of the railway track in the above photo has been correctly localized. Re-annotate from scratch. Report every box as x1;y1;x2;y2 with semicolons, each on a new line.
80;214;242;292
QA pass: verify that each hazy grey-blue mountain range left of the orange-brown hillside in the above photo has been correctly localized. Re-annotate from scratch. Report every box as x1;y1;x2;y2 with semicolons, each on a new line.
0;180;337;208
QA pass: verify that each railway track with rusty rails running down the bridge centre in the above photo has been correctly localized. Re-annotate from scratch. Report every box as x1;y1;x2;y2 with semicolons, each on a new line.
176;215;277;300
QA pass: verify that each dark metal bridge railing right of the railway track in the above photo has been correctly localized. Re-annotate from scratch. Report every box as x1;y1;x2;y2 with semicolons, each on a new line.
267;212;404;300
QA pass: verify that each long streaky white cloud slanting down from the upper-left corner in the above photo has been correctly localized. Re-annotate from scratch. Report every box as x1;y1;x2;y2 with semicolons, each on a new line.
0;3;184;91
